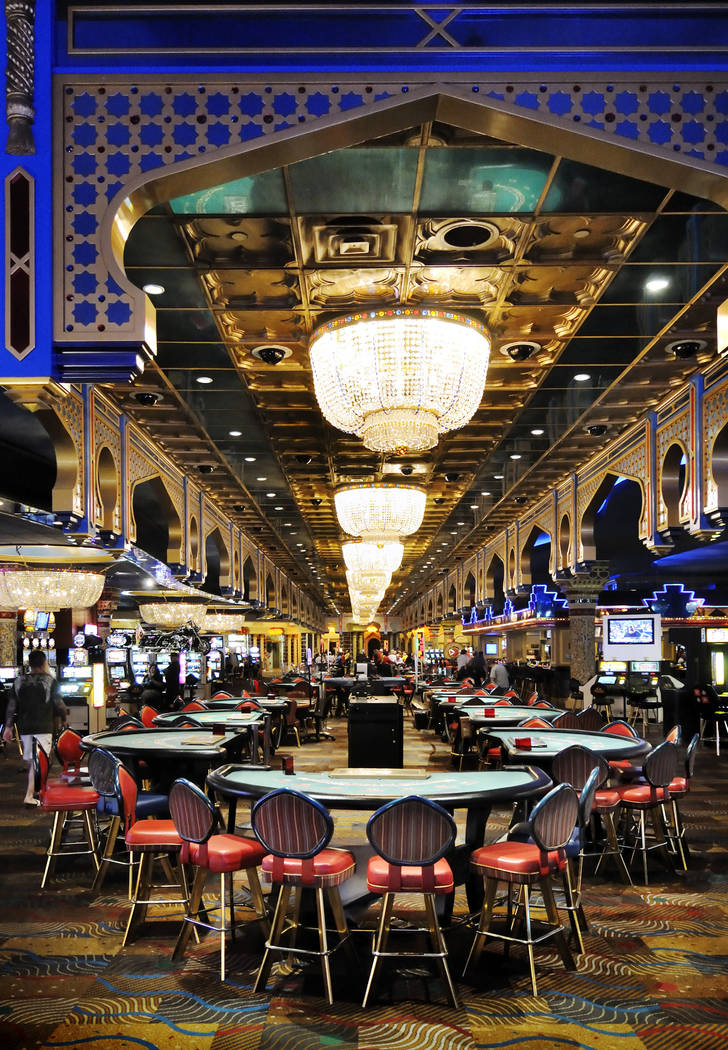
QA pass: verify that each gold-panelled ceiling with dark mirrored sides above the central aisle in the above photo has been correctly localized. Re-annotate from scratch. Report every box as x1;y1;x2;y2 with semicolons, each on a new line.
119;124;728;611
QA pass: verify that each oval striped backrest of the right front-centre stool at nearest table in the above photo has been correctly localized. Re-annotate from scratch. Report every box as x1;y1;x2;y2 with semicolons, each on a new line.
367;795;457;866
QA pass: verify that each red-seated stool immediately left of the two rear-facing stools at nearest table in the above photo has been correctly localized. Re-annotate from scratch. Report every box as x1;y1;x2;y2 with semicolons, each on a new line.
169;780;269;981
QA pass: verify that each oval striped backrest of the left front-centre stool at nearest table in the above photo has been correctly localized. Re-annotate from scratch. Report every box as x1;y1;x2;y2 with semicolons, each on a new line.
251;788;334;858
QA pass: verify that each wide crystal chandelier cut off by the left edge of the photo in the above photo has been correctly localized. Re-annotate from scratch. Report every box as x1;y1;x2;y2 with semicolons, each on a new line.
0;569;105;612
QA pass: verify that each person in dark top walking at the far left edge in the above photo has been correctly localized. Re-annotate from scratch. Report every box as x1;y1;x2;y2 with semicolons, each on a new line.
3;649;68;805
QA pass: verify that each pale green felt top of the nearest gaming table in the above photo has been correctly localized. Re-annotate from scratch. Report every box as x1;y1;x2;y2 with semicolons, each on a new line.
208;765;550;810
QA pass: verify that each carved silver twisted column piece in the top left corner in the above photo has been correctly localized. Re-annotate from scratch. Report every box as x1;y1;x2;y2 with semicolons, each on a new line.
5;0;36;154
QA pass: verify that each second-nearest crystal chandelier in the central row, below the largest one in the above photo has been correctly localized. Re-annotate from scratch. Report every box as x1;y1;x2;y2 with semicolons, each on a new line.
334;484;427;543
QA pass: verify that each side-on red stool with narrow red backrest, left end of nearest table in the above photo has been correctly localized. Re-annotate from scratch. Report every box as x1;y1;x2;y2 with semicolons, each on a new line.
116;763;189;946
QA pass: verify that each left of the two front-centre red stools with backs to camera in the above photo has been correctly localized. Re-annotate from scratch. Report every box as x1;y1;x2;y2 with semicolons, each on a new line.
251;788;356;1005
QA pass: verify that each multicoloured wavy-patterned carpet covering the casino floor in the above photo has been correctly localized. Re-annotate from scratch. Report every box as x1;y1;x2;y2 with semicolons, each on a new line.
0;719;728;1050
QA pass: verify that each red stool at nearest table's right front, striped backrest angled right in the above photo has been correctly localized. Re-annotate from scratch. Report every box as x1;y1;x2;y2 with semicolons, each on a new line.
463;784;579;995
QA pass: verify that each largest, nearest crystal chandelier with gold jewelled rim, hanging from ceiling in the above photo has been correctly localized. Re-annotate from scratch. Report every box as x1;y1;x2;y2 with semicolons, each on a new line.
310;308;491;454
